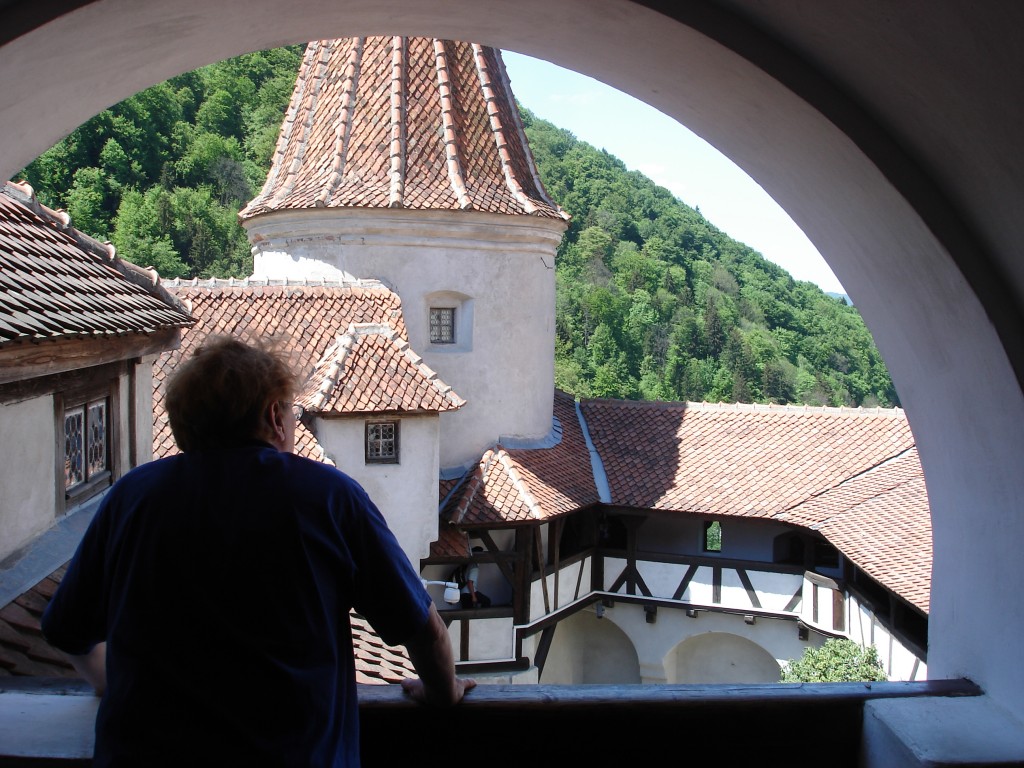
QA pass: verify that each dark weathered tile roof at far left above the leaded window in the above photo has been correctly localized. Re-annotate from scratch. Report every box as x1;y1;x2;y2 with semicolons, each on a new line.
0;183;191;347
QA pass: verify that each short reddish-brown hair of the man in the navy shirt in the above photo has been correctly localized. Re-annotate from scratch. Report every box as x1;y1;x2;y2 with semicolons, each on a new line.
166;336;296;451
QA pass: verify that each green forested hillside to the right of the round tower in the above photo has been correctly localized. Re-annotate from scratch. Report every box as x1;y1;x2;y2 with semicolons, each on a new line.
523;111;898;406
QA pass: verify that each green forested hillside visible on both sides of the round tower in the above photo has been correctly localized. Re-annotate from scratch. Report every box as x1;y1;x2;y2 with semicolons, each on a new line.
14;47;897;406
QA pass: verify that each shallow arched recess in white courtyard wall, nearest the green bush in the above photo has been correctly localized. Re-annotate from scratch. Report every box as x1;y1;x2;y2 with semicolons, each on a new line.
665;632;780;684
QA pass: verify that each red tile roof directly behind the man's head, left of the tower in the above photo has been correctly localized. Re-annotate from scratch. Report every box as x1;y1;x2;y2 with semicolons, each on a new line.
153;280;407;459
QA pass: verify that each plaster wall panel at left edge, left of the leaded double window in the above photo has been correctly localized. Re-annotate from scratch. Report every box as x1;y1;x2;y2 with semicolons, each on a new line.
0;395;57;560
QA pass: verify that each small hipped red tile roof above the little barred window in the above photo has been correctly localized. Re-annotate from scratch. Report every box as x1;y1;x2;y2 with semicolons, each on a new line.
296;323;466;415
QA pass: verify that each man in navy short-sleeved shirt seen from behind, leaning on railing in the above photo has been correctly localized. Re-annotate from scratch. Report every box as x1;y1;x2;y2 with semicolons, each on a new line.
43;338;474;766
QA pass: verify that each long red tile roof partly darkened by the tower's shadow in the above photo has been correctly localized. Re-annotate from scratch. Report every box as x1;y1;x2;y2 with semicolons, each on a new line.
582;400;913;517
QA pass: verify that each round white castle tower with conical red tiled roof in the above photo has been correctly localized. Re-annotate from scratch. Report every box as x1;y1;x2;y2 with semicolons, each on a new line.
240;37;568;468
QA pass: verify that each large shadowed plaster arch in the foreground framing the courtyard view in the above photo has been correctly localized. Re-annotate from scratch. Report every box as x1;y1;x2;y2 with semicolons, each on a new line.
0;0;1024;716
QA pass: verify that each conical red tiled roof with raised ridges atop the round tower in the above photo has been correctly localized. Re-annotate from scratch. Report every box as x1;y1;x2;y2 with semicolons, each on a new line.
240;37;567;219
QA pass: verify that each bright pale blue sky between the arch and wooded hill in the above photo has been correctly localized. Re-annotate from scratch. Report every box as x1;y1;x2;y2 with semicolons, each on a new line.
502;51;846;293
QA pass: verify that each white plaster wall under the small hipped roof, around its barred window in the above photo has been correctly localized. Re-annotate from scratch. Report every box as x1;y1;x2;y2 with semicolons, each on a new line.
316;415;438;567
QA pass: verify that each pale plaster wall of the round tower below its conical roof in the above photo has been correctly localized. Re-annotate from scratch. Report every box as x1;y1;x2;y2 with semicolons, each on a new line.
246;209;564;467
